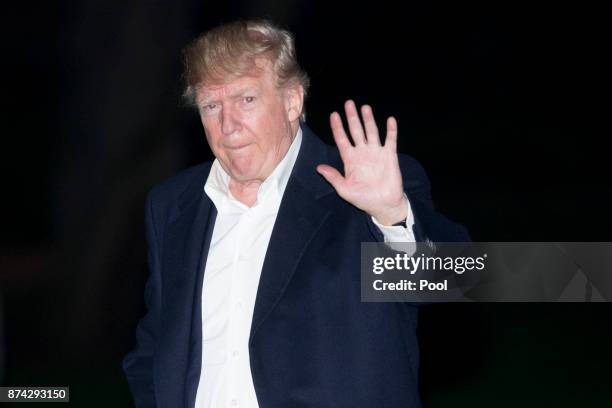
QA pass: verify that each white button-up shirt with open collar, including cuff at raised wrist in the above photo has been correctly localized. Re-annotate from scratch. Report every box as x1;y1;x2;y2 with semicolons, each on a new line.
195;129;414;408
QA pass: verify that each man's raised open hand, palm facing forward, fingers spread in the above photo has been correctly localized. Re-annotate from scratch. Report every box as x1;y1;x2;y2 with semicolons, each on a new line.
317;100;408;225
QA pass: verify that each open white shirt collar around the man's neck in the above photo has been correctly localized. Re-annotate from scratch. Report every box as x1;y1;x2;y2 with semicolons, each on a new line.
204;128;302;213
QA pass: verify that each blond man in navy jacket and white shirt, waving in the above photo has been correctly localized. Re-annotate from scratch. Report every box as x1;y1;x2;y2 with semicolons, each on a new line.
124;21;468;408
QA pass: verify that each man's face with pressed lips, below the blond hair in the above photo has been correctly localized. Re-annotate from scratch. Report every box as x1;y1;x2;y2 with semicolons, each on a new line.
196;62;302;182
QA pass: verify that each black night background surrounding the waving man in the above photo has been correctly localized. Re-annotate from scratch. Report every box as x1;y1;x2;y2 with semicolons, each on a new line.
0;0;612;407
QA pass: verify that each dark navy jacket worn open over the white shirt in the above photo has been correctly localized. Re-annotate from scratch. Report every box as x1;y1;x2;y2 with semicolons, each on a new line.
123;124;469;408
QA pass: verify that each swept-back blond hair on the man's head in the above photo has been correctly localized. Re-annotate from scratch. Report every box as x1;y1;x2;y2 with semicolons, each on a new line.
183;20;310;119
